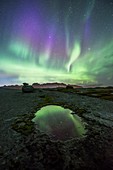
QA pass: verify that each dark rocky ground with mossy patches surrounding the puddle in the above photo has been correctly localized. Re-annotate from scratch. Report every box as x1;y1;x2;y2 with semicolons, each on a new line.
0;88;113;170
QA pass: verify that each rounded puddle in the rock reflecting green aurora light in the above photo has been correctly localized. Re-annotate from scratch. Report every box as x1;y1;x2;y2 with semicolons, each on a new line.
32;105;86;141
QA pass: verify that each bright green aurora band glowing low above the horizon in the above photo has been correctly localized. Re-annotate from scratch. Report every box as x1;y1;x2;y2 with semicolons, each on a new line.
0;39;113;84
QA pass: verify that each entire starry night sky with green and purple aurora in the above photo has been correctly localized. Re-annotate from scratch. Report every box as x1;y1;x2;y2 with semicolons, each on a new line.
0;0;113;85
